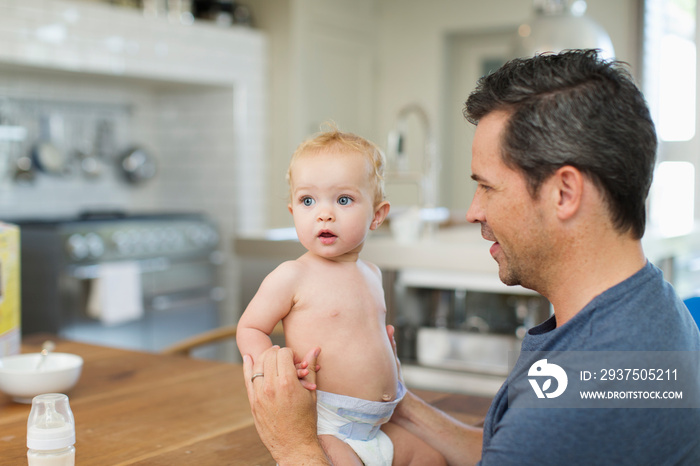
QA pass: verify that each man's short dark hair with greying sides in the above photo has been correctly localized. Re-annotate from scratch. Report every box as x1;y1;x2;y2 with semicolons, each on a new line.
464;50;657;239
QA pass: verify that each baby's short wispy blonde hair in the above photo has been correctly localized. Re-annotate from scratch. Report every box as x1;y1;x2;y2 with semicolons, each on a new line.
287;124;386;205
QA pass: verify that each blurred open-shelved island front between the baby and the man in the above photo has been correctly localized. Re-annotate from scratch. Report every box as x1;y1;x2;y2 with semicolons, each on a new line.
387;268;551;395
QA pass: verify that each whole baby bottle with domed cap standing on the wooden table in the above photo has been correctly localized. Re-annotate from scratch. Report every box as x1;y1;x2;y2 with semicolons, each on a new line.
27;393;75;466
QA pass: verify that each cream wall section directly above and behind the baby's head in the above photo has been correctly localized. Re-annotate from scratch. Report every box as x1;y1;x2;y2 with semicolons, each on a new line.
249;0;379;227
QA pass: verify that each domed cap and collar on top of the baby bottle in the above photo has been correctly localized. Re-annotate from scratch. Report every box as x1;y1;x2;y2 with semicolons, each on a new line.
27;393;75;450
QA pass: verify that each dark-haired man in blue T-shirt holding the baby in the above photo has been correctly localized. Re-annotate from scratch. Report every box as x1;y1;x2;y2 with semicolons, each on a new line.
244;50;700;465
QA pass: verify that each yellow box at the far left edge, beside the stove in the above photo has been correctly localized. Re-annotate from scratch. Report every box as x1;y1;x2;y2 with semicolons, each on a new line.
0;222;21;356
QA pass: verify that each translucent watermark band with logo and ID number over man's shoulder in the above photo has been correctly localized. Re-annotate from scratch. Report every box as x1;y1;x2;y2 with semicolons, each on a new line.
507;350;700;409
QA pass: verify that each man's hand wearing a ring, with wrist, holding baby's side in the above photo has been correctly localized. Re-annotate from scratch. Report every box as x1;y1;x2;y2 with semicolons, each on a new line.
243;346;329;465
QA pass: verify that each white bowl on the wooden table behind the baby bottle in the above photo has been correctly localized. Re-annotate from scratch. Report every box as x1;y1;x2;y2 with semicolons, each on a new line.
0;353;83;403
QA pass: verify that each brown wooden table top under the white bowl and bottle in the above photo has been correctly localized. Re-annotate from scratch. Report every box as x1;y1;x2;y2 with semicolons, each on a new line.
0;336;490;466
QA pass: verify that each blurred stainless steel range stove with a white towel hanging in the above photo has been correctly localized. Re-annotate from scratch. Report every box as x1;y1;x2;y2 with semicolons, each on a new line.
6;212;224;351
